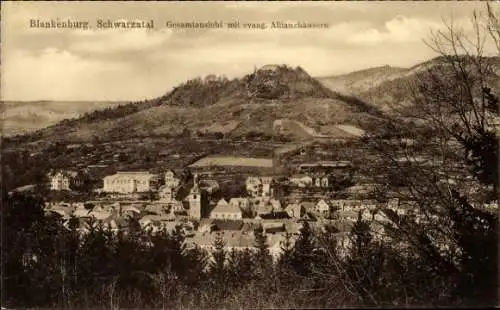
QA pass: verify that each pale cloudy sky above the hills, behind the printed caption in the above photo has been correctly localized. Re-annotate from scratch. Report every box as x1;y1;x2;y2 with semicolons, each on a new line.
0;1;499;101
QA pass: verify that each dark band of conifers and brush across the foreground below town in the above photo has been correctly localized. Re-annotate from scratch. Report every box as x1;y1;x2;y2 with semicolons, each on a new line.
1;188;496;309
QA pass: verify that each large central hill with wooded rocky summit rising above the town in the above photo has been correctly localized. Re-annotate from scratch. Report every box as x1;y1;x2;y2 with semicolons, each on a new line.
6;65;380;147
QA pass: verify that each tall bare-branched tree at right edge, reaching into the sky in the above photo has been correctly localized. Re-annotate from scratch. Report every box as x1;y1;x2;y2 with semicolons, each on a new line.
369;5;500;305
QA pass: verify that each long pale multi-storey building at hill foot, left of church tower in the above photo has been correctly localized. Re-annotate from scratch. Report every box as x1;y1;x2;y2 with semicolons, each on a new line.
103;172;159;194
